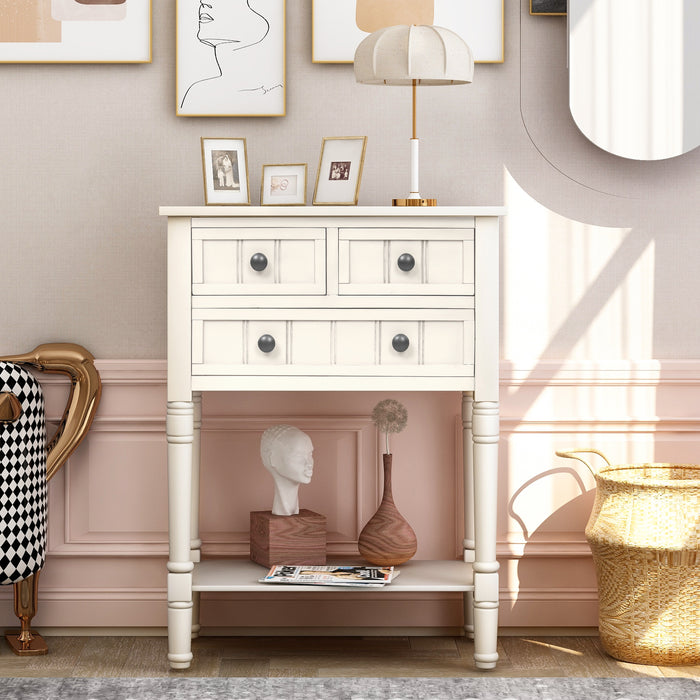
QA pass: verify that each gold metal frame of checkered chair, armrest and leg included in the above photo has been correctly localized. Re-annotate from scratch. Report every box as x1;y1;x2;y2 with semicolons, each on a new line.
0;343;102;656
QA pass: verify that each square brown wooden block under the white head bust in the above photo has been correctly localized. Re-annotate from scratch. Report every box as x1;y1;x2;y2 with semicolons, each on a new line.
250;508;326;566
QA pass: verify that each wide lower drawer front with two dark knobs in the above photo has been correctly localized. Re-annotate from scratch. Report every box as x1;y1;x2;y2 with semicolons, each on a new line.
192;309;474;376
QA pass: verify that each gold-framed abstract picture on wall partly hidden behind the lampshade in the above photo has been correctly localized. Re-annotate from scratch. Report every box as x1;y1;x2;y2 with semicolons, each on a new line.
311;0;504;63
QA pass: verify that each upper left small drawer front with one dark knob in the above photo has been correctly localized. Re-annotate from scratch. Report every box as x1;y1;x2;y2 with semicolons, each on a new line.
192;228;326;295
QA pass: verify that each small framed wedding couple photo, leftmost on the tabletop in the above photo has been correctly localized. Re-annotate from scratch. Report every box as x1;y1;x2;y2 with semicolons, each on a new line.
202;137;250;204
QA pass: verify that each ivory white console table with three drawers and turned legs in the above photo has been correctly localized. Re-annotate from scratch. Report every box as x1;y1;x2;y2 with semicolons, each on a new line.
160;206;505;668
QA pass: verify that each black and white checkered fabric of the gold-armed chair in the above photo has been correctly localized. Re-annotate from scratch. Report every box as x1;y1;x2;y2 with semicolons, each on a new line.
0;362;46;585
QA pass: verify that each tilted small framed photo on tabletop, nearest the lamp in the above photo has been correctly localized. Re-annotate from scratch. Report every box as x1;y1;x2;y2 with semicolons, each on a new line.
313;136;367;204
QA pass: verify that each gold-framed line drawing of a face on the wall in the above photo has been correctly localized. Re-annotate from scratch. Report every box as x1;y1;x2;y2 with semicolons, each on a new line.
175;0;285;117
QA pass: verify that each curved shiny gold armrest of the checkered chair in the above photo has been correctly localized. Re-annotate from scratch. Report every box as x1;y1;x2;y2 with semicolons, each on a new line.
0;343;102;480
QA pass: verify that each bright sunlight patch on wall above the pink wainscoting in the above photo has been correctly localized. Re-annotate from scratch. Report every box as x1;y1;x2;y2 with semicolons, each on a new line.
502;170;654;362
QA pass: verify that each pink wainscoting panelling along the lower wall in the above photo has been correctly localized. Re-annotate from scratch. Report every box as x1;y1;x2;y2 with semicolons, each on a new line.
0;360;700;634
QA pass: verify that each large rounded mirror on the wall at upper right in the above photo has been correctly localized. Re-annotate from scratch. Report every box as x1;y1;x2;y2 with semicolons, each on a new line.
568;0;700;160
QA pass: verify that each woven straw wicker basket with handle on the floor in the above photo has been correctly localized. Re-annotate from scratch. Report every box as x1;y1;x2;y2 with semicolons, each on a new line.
557;450;700;665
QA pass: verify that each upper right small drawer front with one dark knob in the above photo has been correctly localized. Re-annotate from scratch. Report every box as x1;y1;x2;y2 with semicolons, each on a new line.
338;228;474;296
